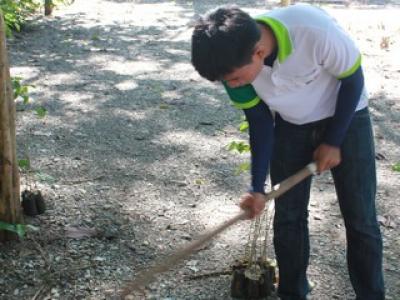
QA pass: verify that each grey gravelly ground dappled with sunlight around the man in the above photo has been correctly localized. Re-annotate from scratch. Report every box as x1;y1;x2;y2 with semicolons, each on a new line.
0;0;400;300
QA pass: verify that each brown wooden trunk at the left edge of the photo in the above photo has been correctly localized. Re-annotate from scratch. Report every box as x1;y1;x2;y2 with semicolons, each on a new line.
0;12;23;241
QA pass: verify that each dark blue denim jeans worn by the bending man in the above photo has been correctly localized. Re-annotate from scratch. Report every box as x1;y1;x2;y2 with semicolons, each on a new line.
271;108;385;300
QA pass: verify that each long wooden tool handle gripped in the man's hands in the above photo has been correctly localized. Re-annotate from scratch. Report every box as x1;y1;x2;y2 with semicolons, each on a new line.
121;163;317;299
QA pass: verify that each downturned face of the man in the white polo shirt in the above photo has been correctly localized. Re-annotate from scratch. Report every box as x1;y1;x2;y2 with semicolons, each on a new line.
223;49;265;88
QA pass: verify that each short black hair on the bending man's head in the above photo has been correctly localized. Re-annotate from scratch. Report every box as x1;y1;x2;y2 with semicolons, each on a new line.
192;6;261;81
